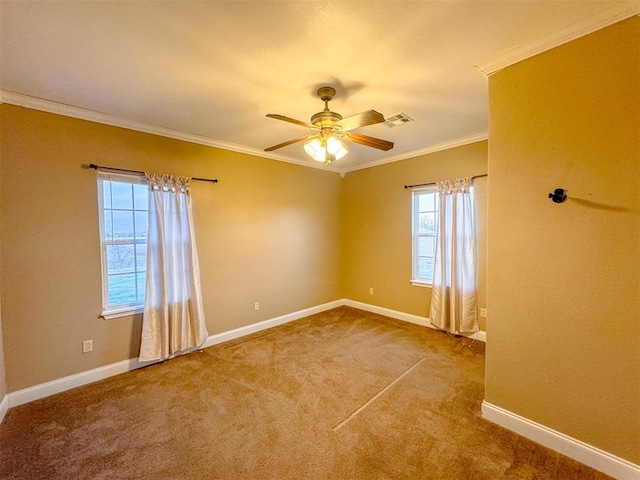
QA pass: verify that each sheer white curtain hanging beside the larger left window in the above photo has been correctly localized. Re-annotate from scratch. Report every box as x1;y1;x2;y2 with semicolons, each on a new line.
140;173;208;361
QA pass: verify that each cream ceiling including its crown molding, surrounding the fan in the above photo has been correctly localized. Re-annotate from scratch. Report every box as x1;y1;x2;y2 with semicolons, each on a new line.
0;0;640;173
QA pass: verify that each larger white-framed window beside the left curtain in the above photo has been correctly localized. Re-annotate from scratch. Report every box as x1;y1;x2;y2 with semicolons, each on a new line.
98;173;149;318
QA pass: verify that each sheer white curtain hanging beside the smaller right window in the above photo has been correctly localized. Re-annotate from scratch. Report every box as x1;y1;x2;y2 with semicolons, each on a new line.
430;177;478;333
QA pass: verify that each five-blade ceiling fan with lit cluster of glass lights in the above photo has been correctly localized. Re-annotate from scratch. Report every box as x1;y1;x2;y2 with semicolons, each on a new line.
264;87;393;165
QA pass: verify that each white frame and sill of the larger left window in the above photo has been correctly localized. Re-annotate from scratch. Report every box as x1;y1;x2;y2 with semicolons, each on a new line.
97;172;149;320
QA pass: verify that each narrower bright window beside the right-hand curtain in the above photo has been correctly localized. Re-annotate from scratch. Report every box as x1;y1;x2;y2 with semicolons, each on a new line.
411;187;438;285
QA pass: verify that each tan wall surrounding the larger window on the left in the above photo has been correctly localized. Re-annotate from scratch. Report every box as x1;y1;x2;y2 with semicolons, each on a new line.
0;104;341;392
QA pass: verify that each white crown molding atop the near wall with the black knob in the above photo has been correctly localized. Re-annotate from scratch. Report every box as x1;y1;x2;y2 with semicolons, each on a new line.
474;2;640;76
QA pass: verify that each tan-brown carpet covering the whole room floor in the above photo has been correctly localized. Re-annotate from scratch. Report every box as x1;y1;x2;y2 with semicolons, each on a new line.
0;307;608;480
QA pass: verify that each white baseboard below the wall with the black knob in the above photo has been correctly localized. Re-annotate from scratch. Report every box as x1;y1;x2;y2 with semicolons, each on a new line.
482;401;640;480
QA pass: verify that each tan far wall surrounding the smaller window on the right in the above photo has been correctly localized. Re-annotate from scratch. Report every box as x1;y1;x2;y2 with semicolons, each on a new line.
341;141;487;327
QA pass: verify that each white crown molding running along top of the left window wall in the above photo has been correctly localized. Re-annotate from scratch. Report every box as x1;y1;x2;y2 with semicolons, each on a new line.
0;90;338;173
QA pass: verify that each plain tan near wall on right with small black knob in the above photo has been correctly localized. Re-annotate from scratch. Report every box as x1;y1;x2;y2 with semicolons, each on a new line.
485;16;640;464
